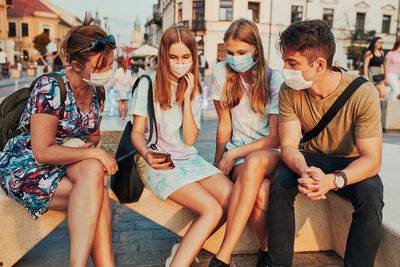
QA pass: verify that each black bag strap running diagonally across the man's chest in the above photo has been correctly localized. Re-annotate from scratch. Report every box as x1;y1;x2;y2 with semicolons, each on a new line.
300;76;368;144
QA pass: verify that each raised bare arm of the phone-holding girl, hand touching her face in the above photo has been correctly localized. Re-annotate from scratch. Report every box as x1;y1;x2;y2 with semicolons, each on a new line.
182;73;199;146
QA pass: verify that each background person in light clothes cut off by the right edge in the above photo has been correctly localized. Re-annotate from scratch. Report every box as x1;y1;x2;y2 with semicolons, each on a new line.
385;40;400;100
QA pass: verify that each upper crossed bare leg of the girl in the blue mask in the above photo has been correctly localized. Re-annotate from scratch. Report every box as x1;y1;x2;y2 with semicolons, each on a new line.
216;150;280;263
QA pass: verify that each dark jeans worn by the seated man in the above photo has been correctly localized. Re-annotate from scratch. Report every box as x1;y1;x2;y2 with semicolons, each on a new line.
267;153;384;267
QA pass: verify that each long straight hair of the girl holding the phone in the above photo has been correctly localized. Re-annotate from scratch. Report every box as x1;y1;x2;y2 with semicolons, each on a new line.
154;25;202;109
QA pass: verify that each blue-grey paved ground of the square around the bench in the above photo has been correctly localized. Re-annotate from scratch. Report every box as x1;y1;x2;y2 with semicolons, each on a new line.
4;73;400;267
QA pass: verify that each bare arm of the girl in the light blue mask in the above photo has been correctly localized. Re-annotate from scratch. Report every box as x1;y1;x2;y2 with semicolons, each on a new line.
214;100;232;165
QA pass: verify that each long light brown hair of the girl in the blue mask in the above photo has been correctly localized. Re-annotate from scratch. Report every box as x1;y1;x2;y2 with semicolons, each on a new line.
221;18;269;114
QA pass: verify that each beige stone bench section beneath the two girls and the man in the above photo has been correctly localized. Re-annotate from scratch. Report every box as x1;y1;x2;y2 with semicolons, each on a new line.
105;133;400;267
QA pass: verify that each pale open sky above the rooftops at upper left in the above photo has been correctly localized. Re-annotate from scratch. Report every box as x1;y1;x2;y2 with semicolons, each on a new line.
49;0;157;45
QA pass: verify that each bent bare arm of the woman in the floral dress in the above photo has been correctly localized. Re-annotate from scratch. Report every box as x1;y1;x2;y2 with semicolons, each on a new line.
31;113;118;175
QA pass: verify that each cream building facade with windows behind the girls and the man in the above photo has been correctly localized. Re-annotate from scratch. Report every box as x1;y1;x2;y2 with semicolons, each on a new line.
158;0;399;69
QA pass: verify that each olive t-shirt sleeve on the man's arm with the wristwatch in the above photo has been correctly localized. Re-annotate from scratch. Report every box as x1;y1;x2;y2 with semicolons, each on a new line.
355;84;382;139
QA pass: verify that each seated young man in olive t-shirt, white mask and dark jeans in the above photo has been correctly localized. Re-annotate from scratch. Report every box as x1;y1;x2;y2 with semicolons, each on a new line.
257;20;384;267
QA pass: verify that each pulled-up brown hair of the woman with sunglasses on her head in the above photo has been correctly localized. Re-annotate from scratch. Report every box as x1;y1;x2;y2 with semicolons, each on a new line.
61;12;115;70
